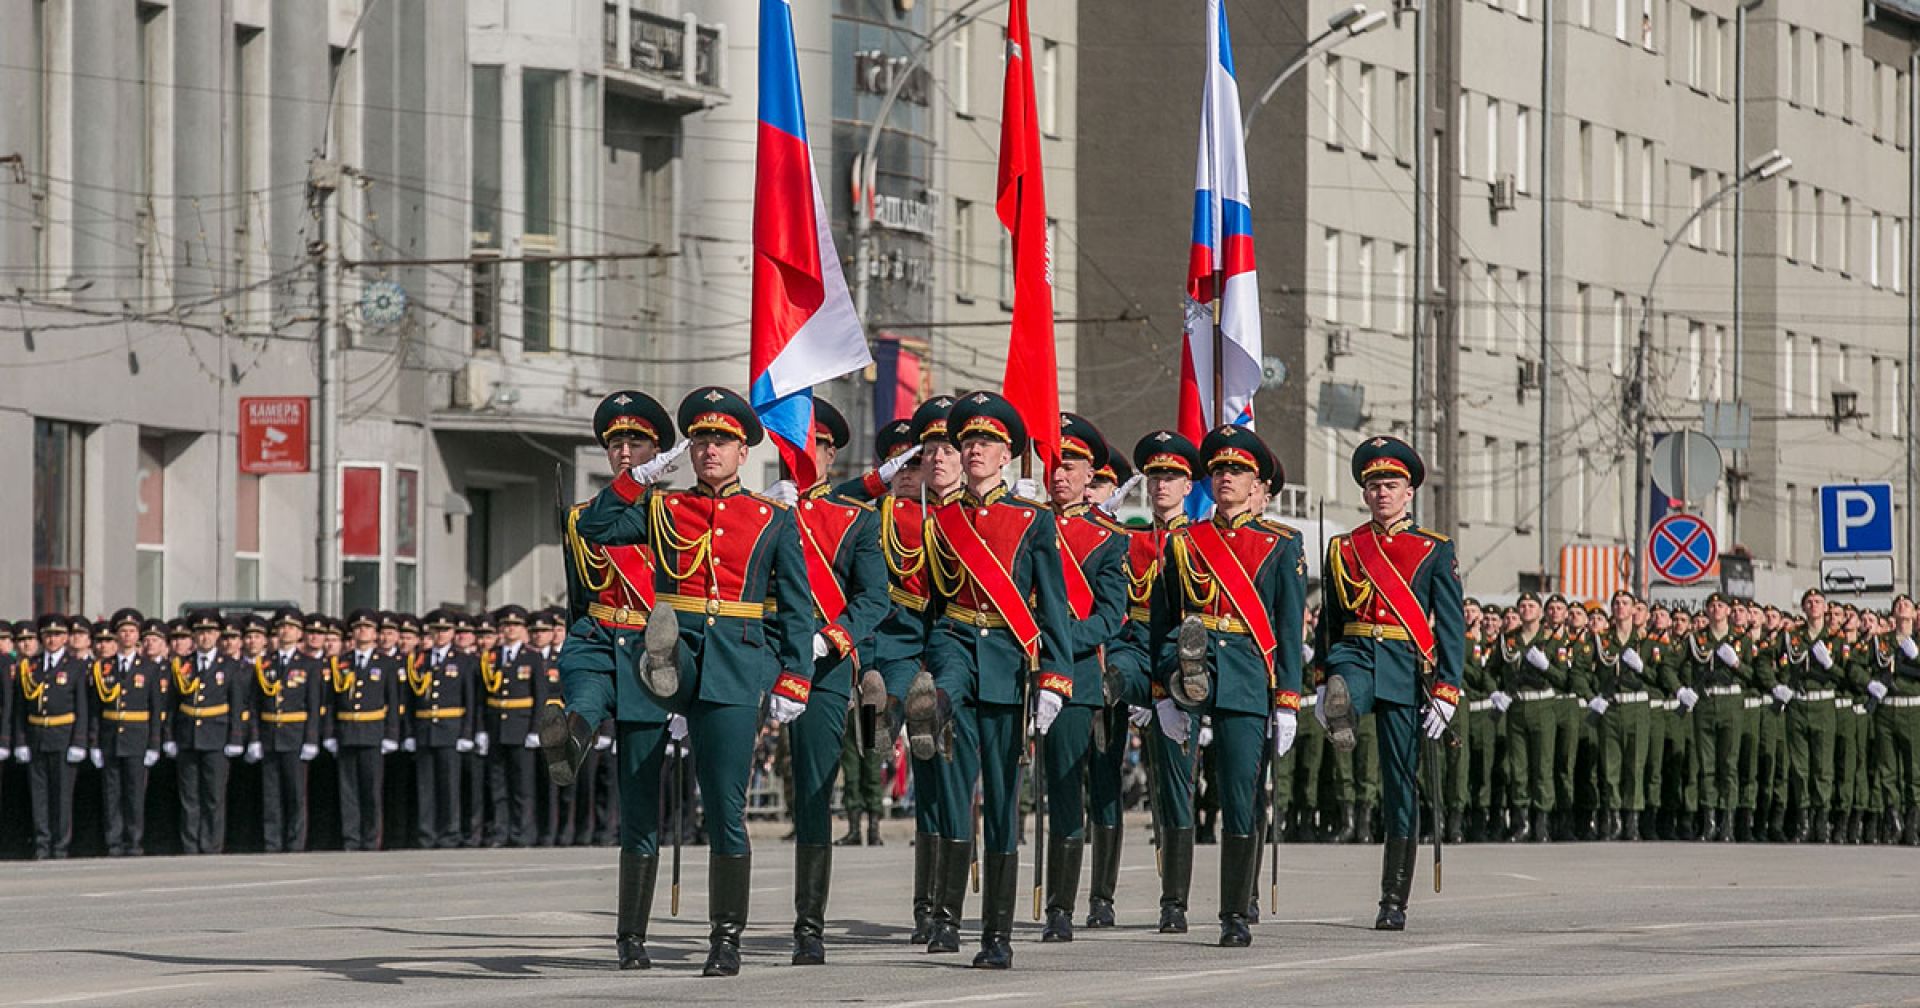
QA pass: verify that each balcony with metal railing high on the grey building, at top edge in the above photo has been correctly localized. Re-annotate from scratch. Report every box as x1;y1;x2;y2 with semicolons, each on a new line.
601;0;728;111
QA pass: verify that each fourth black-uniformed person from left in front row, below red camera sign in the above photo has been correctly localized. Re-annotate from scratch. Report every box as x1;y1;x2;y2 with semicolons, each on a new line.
250;611;330;854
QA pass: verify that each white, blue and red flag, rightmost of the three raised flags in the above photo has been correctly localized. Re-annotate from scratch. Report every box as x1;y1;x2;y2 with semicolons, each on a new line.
1179;0;1260;513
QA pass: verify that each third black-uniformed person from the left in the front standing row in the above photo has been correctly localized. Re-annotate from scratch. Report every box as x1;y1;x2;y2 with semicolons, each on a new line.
167;612;253;854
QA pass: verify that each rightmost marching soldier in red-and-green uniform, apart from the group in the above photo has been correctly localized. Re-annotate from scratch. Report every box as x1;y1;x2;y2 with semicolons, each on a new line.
1317;438;1467;931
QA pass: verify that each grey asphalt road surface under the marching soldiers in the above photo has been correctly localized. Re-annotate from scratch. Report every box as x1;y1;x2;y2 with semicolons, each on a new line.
0;824;1920;1008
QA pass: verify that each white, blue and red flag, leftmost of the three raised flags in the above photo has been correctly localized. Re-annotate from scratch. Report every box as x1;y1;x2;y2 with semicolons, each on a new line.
747;0;874;488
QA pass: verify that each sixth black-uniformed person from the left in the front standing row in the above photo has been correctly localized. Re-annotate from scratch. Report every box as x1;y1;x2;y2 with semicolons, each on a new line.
405;611;480;849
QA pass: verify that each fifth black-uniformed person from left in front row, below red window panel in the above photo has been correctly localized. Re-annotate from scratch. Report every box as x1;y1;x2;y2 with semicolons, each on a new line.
326;611;399;851
